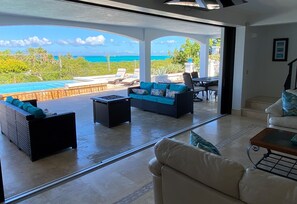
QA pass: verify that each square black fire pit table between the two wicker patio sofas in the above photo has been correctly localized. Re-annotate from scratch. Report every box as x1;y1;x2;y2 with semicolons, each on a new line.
91;95;131;127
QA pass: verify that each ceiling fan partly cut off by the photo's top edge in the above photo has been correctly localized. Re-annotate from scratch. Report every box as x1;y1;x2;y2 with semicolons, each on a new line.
164;0;247;10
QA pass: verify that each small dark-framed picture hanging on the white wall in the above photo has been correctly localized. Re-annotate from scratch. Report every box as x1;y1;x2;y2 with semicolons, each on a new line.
272;38;289;61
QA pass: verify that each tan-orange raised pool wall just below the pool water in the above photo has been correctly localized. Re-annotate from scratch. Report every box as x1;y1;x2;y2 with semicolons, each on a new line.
2;84;107;101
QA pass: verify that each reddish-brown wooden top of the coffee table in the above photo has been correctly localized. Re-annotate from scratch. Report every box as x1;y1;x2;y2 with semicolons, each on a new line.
250;128;297;156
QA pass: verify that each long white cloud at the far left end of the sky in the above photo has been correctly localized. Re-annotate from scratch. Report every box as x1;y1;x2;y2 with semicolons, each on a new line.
0;36;52;47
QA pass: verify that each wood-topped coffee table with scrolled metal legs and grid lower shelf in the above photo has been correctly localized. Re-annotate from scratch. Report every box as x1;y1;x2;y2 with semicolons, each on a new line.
247;128;297;180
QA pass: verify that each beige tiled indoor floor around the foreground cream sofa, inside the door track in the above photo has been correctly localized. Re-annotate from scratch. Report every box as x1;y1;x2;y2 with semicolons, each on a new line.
15;116;266;204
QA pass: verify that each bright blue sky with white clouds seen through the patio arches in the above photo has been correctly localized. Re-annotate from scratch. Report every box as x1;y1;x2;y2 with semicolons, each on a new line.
0;26;185;56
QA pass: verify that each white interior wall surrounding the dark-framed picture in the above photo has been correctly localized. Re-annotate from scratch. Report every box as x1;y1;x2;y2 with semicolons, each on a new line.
243;24;297;99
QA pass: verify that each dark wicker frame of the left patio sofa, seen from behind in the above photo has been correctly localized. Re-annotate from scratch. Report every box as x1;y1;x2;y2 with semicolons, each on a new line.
0;100;77;161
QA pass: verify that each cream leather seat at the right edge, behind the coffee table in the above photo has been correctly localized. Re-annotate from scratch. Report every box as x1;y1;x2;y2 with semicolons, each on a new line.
265;98;297;132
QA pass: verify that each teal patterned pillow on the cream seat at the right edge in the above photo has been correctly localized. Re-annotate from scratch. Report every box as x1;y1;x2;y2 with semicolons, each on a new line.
282;91;297;116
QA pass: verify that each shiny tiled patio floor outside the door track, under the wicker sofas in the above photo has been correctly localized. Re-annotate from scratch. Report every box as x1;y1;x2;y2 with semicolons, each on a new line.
0;85;218;201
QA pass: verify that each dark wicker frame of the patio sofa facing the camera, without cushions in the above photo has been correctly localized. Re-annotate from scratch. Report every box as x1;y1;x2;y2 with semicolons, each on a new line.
128;86;193;118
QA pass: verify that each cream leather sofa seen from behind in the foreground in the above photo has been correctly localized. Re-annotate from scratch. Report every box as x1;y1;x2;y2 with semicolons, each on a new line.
149;139;297;204
